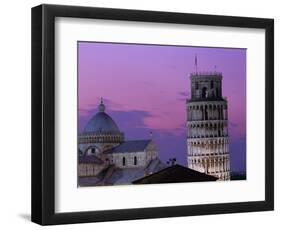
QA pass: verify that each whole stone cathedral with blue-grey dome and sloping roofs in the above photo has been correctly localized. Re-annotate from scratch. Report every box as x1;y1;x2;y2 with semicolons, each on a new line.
78;100;164;186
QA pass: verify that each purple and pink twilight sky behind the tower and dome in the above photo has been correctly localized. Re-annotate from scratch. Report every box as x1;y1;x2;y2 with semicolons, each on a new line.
78;42;246;171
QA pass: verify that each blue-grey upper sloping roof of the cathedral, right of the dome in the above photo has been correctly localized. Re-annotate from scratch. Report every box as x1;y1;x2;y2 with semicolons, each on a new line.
105;140;151;153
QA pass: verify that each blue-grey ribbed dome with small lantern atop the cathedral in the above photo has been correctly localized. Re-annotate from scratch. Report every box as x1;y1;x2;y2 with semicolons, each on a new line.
84;100;120;134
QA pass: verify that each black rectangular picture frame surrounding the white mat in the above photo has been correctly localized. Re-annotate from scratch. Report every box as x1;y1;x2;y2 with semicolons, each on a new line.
31;5;274;225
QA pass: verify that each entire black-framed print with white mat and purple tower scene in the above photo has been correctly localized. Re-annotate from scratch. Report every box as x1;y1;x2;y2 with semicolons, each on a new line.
32;5;274;225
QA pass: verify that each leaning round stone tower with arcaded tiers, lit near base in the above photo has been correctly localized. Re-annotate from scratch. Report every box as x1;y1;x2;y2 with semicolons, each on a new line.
186;72;230;180
